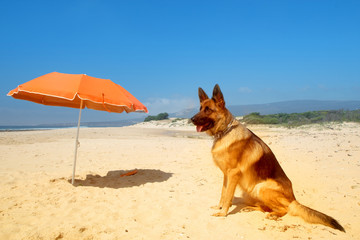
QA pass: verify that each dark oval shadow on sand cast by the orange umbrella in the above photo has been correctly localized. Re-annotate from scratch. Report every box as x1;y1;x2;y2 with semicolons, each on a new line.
69;169;173;189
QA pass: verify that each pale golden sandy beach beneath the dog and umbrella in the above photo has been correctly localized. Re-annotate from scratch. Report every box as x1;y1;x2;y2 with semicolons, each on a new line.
0;120;360;240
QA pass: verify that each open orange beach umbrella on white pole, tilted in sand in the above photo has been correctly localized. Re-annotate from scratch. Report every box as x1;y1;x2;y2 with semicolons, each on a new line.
8;72;148;184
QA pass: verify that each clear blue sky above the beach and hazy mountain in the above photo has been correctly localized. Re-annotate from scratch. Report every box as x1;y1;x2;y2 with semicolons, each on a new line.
0;0;360;125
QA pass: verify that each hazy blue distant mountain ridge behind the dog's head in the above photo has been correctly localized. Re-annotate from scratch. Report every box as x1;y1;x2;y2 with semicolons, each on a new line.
170;100;360;118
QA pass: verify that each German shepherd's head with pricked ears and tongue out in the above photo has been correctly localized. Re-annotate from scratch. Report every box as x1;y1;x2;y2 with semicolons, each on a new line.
191;84;232;136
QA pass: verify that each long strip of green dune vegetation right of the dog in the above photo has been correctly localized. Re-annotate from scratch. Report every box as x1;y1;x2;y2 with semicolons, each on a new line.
242;109;360;126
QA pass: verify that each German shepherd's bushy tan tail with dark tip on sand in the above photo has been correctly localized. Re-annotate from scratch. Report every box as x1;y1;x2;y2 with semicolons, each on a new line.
288;200;345;232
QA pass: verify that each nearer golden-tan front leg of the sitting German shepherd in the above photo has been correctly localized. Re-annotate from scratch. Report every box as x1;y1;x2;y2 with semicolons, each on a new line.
213;171;239;217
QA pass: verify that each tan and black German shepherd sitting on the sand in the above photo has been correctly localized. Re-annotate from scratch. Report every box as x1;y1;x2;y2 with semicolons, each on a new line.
191;84;345;232
